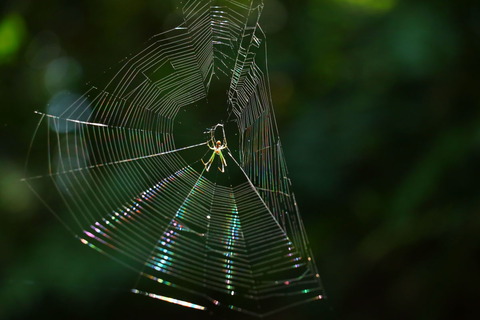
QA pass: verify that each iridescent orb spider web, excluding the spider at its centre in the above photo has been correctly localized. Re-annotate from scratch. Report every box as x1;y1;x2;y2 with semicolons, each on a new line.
24;0;323;316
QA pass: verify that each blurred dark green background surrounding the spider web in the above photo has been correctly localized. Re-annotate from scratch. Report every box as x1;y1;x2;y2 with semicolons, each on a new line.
0;0;480;319
